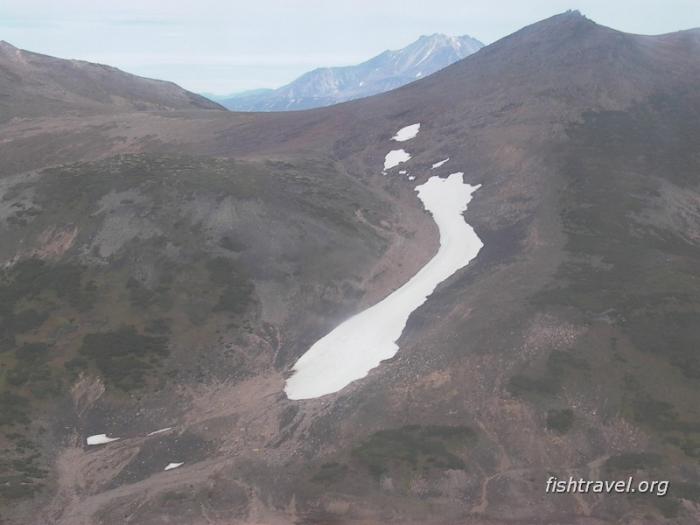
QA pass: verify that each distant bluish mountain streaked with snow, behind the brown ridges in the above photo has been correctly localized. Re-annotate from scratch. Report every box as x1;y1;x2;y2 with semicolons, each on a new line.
217;33;483;111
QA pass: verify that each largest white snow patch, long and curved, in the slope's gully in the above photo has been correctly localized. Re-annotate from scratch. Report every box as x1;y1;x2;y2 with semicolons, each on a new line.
285;173;483;399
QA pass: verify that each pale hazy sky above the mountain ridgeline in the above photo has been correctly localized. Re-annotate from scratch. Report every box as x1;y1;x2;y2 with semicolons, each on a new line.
0;0;700;94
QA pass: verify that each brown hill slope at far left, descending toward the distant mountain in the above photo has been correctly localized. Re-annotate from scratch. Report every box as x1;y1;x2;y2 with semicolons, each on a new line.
0;41;222;121
